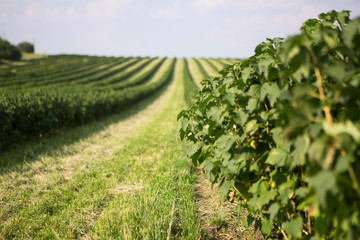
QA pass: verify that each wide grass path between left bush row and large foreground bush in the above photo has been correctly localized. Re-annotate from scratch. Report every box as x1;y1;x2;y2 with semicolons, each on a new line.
0;60;200;239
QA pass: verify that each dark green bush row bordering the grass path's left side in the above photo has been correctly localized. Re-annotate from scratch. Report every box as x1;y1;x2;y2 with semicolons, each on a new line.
0;59;175;149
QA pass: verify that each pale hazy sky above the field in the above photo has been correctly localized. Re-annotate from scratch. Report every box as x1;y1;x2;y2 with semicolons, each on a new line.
0;0;360;58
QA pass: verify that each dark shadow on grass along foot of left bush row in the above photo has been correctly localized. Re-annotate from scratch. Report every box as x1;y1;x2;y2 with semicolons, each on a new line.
0;78;173;175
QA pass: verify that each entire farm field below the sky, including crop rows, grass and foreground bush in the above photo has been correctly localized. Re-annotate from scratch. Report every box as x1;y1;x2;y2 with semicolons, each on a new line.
0;11;360;240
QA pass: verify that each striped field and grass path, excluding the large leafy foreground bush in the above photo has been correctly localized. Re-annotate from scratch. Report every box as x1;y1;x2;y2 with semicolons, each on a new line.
0;55;248;239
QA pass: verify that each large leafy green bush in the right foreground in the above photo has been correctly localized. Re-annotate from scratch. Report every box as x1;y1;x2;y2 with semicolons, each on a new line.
178;11;360;239
